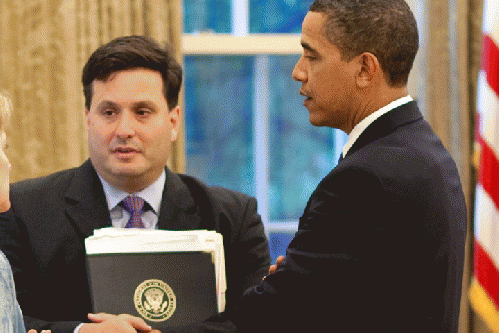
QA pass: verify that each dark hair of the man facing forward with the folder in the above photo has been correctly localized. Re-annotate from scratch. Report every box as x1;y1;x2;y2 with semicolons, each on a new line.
81;36;182;110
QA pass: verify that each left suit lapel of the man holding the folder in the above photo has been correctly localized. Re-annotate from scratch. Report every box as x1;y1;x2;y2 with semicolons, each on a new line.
64;160;111;238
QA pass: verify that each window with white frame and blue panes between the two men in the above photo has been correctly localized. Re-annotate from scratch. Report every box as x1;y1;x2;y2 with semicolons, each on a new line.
183;0;346;260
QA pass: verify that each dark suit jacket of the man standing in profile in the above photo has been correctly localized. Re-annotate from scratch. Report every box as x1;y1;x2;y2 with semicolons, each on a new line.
205;102;467;333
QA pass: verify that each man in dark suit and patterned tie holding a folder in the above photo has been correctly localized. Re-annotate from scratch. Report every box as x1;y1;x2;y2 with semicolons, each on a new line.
0;36;270;333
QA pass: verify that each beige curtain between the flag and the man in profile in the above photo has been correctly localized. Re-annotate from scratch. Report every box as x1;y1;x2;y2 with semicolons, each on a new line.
418;0;488;333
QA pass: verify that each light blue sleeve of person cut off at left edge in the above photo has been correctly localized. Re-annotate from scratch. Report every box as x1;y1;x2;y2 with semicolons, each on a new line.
0;251;26;333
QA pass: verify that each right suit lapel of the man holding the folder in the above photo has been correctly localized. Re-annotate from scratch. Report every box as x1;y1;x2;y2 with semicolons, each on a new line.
158;169;201;230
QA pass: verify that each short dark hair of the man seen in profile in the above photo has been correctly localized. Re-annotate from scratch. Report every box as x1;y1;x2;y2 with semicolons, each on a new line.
309;0;419;86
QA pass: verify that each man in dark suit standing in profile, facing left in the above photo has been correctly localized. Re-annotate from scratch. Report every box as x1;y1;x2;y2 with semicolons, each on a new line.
193;0;467;333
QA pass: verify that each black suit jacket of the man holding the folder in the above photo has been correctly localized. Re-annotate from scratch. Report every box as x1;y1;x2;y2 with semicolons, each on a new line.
0;161;270;333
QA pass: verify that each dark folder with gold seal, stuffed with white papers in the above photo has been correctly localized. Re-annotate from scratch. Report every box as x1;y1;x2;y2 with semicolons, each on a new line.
85;228;226;329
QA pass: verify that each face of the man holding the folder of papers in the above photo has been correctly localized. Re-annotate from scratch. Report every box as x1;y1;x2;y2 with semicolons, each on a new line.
85;68;180;192
